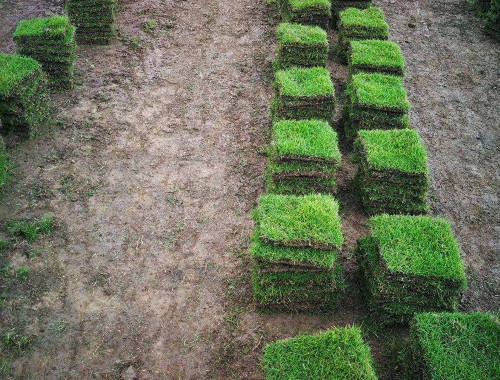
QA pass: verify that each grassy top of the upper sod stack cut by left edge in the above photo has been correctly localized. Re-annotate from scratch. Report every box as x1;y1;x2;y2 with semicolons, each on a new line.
0;53;40;97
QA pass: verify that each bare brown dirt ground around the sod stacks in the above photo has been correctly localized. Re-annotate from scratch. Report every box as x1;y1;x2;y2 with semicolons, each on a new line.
0;0;500;380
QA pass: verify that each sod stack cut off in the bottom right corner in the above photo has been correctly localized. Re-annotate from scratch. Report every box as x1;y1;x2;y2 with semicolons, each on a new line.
403;313;500;380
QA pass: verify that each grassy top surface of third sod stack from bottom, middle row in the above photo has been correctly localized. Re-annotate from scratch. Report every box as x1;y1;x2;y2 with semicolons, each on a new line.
271;120;342;163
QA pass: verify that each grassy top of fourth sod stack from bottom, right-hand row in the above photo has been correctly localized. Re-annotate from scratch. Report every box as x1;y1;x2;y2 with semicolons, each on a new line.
348;73;410;112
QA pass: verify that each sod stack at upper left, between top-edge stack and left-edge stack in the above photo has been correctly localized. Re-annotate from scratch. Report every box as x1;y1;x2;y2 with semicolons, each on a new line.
14;16;76;88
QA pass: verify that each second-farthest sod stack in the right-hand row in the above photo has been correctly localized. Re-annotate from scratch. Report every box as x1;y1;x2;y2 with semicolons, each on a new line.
337;7;389;62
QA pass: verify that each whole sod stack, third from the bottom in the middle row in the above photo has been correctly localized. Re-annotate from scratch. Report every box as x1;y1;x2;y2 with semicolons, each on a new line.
267;120;341;194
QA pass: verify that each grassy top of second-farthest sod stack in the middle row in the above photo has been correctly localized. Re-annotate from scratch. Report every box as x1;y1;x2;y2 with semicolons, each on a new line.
276;22;328;47
